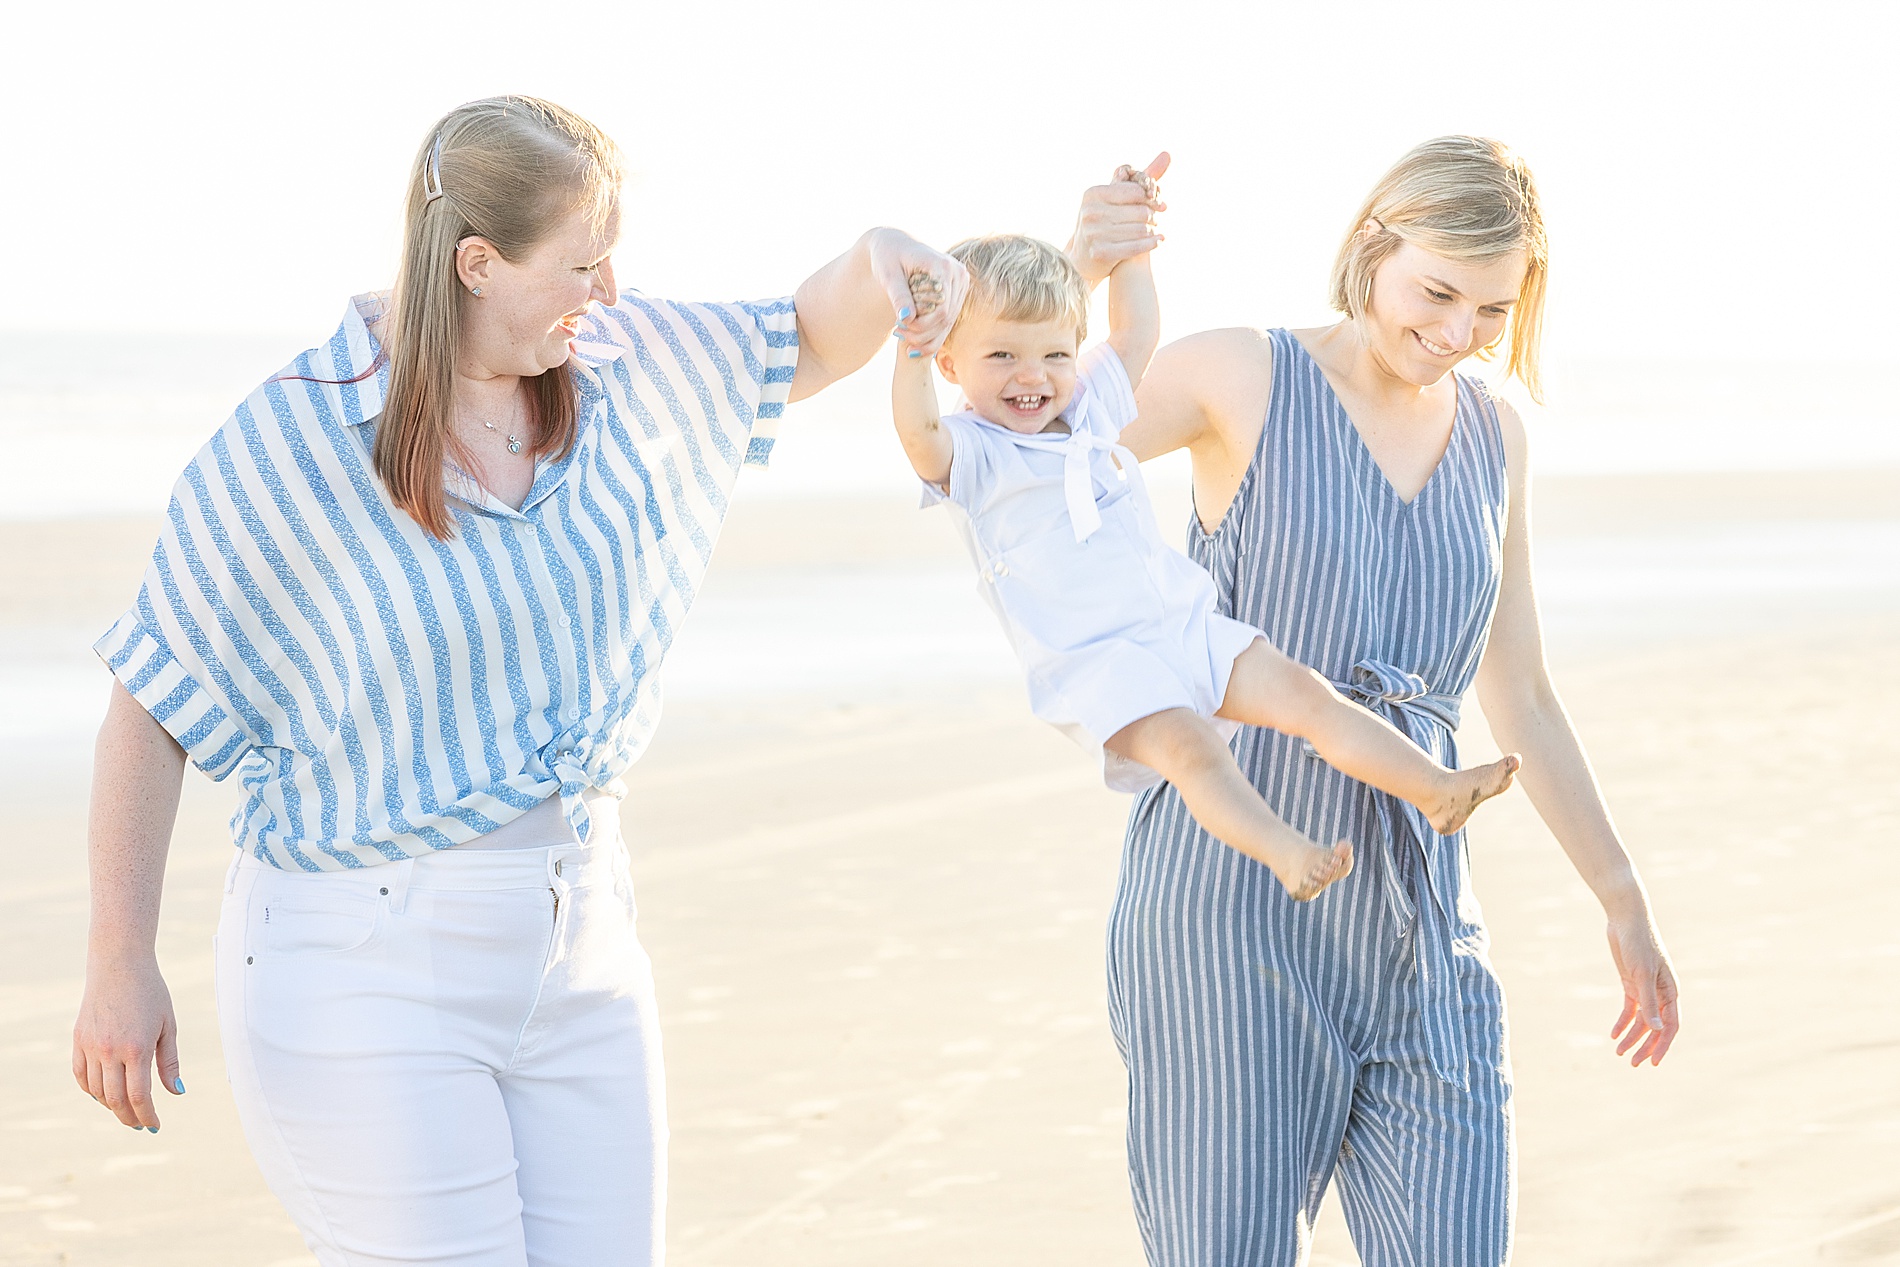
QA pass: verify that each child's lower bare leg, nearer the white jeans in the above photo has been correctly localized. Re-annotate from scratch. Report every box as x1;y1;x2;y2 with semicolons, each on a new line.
1108;709;1353;902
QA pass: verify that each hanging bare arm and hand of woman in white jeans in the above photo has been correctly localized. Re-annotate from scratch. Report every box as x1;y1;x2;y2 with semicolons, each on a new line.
72;682;184;1132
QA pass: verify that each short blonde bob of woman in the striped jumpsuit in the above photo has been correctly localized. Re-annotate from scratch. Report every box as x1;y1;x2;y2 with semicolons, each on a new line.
1332;137;1550;403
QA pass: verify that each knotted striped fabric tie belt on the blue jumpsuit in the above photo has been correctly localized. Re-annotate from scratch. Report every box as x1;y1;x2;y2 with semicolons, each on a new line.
1332;659;1471;1088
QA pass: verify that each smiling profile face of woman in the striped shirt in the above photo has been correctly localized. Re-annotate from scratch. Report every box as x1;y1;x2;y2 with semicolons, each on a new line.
460;211;619;376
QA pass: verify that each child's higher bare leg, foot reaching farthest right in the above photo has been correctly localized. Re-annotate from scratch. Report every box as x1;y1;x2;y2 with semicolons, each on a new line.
1220;638;1522;836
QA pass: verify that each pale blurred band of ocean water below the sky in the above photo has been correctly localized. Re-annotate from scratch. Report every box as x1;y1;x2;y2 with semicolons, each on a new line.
0;331;1900;520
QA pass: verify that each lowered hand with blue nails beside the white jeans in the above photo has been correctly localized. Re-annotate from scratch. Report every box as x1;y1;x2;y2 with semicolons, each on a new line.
72;959;184;1134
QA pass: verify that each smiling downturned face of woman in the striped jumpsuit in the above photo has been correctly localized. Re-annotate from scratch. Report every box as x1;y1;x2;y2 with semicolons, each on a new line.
1360;241;1528;388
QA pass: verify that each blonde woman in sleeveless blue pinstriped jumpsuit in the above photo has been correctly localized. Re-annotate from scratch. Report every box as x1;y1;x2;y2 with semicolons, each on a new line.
1077;137;1678;1267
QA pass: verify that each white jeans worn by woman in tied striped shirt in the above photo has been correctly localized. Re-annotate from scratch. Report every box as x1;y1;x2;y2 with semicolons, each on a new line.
217;817;667;1267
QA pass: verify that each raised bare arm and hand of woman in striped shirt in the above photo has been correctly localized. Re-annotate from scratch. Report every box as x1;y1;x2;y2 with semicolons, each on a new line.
792;228;969;401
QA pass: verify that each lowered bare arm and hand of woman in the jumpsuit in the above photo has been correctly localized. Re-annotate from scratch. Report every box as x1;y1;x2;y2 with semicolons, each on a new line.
1478;403;1680;1066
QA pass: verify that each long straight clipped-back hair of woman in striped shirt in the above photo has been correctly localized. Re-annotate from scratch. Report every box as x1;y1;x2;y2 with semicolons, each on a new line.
372;97;623;539
